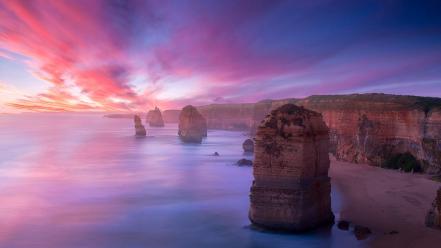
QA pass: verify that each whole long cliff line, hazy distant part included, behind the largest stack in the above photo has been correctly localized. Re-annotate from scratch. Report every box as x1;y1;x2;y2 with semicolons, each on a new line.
191;94;441;173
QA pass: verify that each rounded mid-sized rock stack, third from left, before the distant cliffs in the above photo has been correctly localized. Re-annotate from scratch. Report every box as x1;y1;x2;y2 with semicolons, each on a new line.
178;105;207;143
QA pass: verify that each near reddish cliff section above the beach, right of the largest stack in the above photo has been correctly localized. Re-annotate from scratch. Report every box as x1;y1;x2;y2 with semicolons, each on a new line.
305;94;441;173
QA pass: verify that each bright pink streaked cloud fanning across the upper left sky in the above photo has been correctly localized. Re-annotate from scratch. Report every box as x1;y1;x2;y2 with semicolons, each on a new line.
0;1;148;109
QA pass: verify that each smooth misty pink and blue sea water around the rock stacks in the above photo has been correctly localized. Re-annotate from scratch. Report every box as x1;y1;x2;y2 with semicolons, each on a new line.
0;114;361;248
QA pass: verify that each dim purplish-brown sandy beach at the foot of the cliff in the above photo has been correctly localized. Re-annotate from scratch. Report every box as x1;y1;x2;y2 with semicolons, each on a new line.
330;160;441;247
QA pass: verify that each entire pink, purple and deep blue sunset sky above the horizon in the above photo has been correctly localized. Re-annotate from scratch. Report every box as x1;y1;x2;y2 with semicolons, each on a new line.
0;0;441;113
